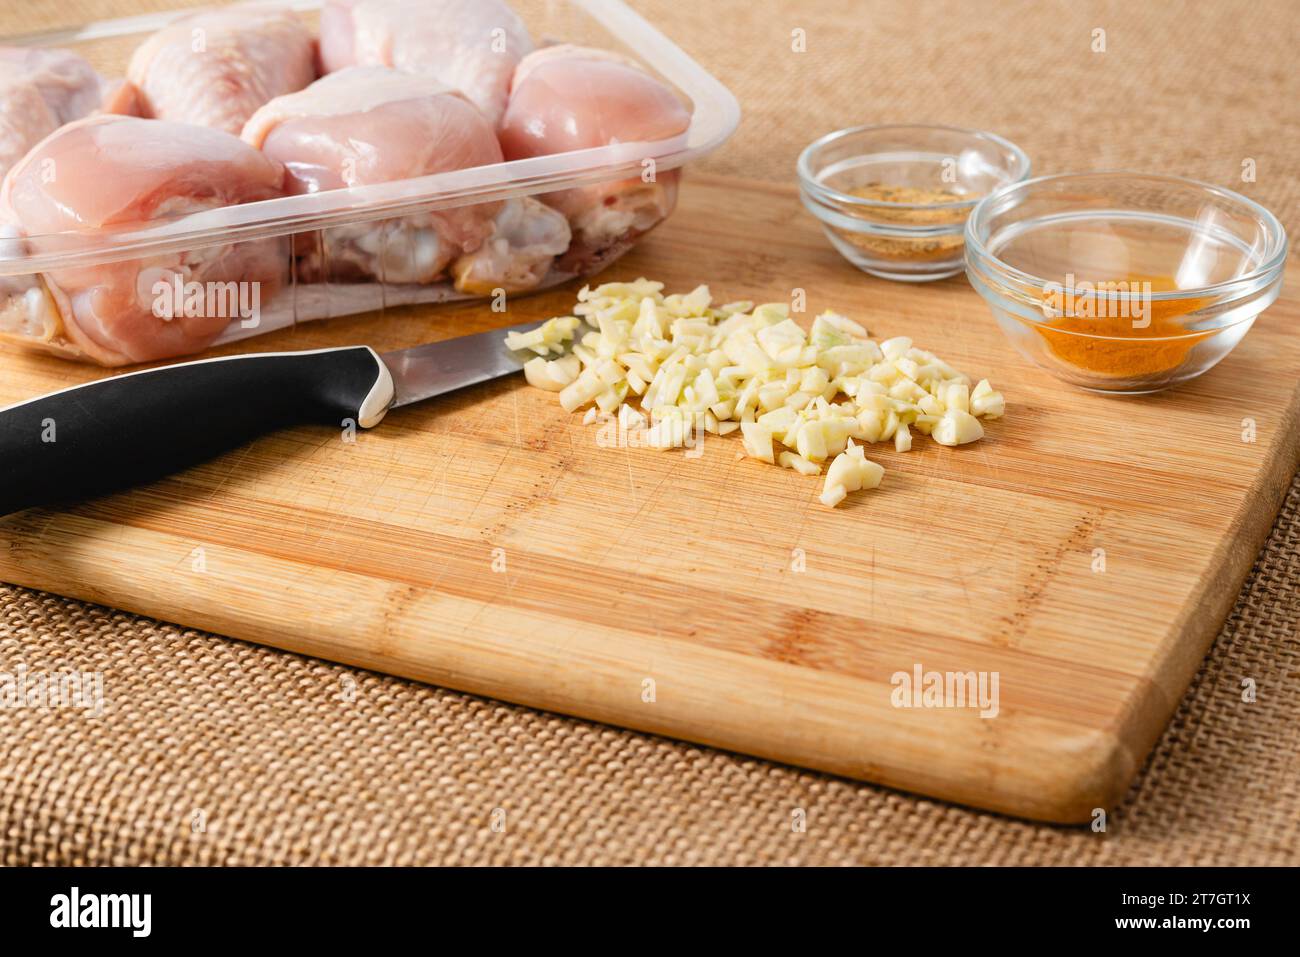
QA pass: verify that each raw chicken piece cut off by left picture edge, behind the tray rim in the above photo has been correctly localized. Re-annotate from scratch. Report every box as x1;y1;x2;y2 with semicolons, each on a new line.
0;47;100;177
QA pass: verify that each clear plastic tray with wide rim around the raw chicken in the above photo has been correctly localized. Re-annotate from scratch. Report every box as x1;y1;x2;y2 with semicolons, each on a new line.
0;0;740;364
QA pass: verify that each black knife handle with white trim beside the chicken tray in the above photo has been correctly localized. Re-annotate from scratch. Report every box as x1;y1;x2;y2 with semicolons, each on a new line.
0;346;393;515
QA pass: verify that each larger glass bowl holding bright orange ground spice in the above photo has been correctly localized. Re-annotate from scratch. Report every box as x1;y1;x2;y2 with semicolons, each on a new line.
966;172;1287;394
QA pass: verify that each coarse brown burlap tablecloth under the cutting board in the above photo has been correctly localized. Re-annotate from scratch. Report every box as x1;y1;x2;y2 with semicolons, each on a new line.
0;0;1300;865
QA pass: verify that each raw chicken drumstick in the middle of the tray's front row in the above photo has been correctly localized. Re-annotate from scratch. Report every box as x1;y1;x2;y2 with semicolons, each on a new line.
243;66;568;290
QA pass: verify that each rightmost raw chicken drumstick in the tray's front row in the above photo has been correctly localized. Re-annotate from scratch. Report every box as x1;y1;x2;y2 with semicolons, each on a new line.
499;44;690;272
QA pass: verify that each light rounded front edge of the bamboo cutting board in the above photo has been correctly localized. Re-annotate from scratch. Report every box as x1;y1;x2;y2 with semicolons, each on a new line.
0;511;1167;822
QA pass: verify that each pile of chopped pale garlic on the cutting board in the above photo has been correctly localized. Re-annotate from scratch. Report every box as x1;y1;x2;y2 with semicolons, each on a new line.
506;278;1006;506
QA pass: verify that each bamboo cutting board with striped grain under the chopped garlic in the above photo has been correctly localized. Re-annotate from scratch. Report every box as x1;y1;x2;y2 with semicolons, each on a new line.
0;177;1300;822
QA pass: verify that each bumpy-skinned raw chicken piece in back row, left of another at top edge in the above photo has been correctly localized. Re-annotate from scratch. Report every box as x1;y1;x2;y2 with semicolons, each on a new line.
104;4;316;134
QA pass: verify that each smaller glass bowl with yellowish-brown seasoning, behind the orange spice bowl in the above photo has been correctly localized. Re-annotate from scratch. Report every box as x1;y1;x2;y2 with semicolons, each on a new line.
798;126;1030;282
